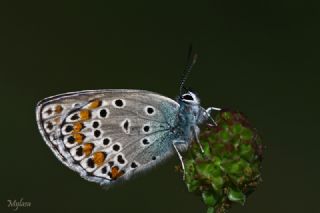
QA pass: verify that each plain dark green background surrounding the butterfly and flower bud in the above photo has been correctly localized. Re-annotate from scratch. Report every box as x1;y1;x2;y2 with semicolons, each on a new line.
0;0;320;213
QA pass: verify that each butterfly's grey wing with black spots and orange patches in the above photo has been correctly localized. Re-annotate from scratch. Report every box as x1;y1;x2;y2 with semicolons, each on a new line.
36;90;179;184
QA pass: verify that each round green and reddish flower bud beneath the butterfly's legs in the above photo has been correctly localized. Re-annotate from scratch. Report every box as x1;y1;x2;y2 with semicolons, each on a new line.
179;110;263;213
